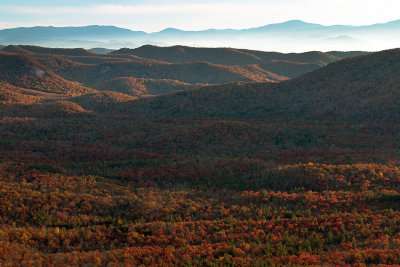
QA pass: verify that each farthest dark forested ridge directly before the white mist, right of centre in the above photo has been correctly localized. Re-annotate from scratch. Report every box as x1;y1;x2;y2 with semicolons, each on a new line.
111;45;363;78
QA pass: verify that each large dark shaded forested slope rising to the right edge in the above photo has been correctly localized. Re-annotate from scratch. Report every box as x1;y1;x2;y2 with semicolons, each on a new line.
118;49;400;122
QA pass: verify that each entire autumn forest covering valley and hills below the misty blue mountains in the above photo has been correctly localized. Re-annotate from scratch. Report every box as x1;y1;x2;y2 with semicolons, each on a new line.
0;46;400;266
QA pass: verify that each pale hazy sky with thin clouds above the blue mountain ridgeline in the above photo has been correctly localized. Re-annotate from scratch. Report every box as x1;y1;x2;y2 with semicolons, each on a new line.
0;0;400;32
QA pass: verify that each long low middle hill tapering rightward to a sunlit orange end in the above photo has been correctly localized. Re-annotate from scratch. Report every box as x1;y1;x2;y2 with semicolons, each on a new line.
40;58;286;89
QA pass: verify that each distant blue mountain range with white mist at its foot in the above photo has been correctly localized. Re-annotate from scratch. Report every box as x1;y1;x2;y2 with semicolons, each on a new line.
0;20;400;52
